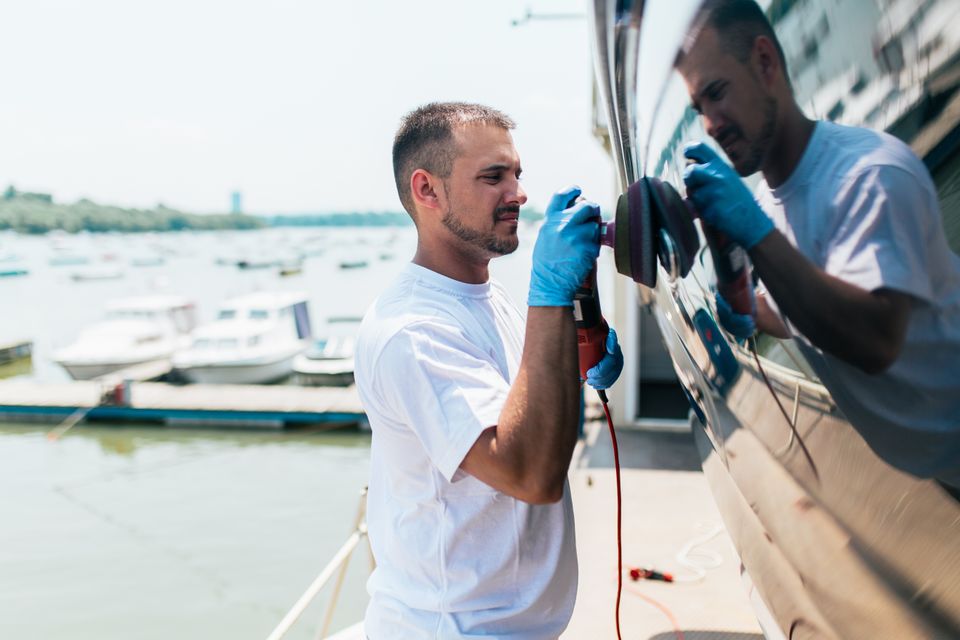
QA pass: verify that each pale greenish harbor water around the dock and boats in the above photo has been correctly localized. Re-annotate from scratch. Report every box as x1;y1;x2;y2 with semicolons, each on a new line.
0;222;535;640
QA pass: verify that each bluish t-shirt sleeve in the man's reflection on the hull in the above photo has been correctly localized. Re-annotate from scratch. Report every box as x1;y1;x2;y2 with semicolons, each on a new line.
825;165;940;302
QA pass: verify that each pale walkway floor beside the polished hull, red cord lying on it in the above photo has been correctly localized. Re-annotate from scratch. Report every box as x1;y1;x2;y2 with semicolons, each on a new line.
561;421;763;640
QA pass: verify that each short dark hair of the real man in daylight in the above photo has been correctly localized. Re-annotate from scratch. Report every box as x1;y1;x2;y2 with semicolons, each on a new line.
393;102;517;217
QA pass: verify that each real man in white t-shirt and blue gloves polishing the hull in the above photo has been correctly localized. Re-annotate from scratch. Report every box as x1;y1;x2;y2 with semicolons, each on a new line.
356;103;623;640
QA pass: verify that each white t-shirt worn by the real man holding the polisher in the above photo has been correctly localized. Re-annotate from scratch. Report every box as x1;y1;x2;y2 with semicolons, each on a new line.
355;264;577;640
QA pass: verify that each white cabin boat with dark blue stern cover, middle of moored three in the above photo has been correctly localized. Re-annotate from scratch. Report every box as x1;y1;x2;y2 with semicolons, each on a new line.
173;292;311;384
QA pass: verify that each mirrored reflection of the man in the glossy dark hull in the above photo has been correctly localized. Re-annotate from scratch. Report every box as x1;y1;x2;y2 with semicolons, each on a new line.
677;0;960;488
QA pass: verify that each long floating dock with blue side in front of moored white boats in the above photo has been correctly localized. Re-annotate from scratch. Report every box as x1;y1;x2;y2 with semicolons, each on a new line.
0;380;366;429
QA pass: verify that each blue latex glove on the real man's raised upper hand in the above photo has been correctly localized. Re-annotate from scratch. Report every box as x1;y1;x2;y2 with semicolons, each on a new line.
527;187;600;307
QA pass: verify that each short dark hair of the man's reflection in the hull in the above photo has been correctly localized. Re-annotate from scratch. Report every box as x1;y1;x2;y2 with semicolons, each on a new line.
694;0;790;78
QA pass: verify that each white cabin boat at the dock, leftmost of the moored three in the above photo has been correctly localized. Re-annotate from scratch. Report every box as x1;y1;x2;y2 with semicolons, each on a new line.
54;295;196;380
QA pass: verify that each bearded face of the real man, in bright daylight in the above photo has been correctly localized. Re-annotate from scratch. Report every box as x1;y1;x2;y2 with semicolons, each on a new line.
442;124;527;258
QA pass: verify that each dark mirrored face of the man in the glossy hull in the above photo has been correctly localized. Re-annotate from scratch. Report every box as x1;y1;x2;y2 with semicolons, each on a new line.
679;28;777;176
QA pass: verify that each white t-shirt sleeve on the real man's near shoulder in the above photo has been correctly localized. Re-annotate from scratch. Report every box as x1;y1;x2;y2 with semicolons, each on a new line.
377;323;510;481
